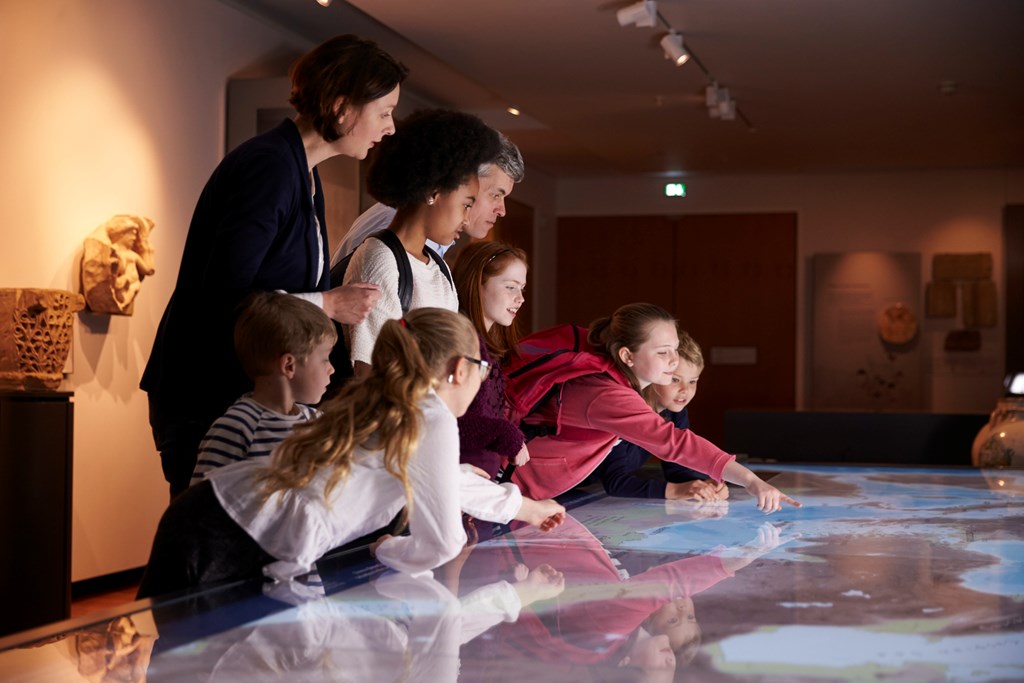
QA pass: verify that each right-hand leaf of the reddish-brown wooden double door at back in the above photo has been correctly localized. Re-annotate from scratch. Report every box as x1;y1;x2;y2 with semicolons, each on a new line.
673;214;797;444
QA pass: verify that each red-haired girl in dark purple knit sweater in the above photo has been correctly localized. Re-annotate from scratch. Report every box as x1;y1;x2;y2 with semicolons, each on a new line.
452;242;529;477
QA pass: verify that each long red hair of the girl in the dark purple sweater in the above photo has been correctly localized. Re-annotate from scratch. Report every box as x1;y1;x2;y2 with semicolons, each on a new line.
452;242;528;361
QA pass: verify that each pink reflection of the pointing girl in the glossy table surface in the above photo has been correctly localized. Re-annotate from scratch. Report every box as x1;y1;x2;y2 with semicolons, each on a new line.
454;515;780;681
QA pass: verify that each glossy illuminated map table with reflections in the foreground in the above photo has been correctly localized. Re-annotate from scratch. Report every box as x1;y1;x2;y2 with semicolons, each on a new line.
0;466;1024;683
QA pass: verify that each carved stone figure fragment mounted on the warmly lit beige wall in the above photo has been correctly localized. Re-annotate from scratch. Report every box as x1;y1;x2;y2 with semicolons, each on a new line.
82;214;156;315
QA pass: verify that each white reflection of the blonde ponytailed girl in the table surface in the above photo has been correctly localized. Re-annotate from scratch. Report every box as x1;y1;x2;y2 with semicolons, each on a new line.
189;573;565;683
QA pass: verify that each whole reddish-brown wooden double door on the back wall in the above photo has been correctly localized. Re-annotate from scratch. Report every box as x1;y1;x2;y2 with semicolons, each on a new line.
556;214;797;443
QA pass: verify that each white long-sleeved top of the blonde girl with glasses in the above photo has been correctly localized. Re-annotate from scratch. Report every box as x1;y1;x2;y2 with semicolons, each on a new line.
207;391;522;581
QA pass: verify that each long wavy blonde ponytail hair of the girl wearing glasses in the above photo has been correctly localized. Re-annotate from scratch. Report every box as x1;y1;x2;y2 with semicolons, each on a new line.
258;308;479;524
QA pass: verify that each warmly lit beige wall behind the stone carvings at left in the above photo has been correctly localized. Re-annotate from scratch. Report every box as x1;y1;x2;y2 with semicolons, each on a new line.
0;0;305;581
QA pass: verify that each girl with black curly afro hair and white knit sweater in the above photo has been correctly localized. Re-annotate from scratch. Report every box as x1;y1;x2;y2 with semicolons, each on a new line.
344;110;501;377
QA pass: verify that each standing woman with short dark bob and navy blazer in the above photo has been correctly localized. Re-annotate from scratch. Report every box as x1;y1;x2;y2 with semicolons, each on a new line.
141;35;408;497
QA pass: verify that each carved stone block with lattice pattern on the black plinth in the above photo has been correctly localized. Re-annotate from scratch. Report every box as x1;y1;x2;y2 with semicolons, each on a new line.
0;289;85;390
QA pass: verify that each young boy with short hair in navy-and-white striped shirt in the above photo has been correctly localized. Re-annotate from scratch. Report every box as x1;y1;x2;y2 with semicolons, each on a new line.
189;292;337;485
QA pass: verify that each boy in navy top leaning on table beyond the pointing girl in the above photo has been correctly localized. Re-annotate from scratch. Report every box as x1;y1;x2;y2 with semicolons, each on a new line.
581;332;729;501
